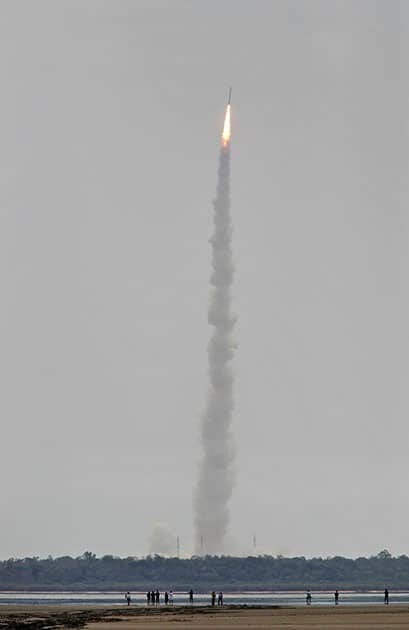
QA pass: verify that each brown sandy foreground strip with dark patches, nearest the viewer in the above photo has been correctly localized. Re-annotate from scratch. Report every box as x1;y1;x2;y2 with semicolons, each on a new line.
0;606;409;630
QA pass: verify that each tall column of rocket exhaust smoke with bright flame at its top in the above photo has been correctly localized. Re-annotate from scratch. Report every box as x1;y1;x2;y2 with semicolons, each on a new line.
194;104;235;554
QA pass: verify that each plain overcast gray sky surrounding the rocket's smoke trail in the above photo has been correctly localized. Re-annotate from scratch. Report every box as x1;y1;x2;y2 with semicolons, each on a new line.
0;0;409;557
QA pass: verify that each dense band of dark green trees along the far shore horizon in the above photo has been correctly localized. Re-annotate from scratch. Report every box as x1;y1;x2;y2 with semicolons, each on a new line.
0;551;409;591
